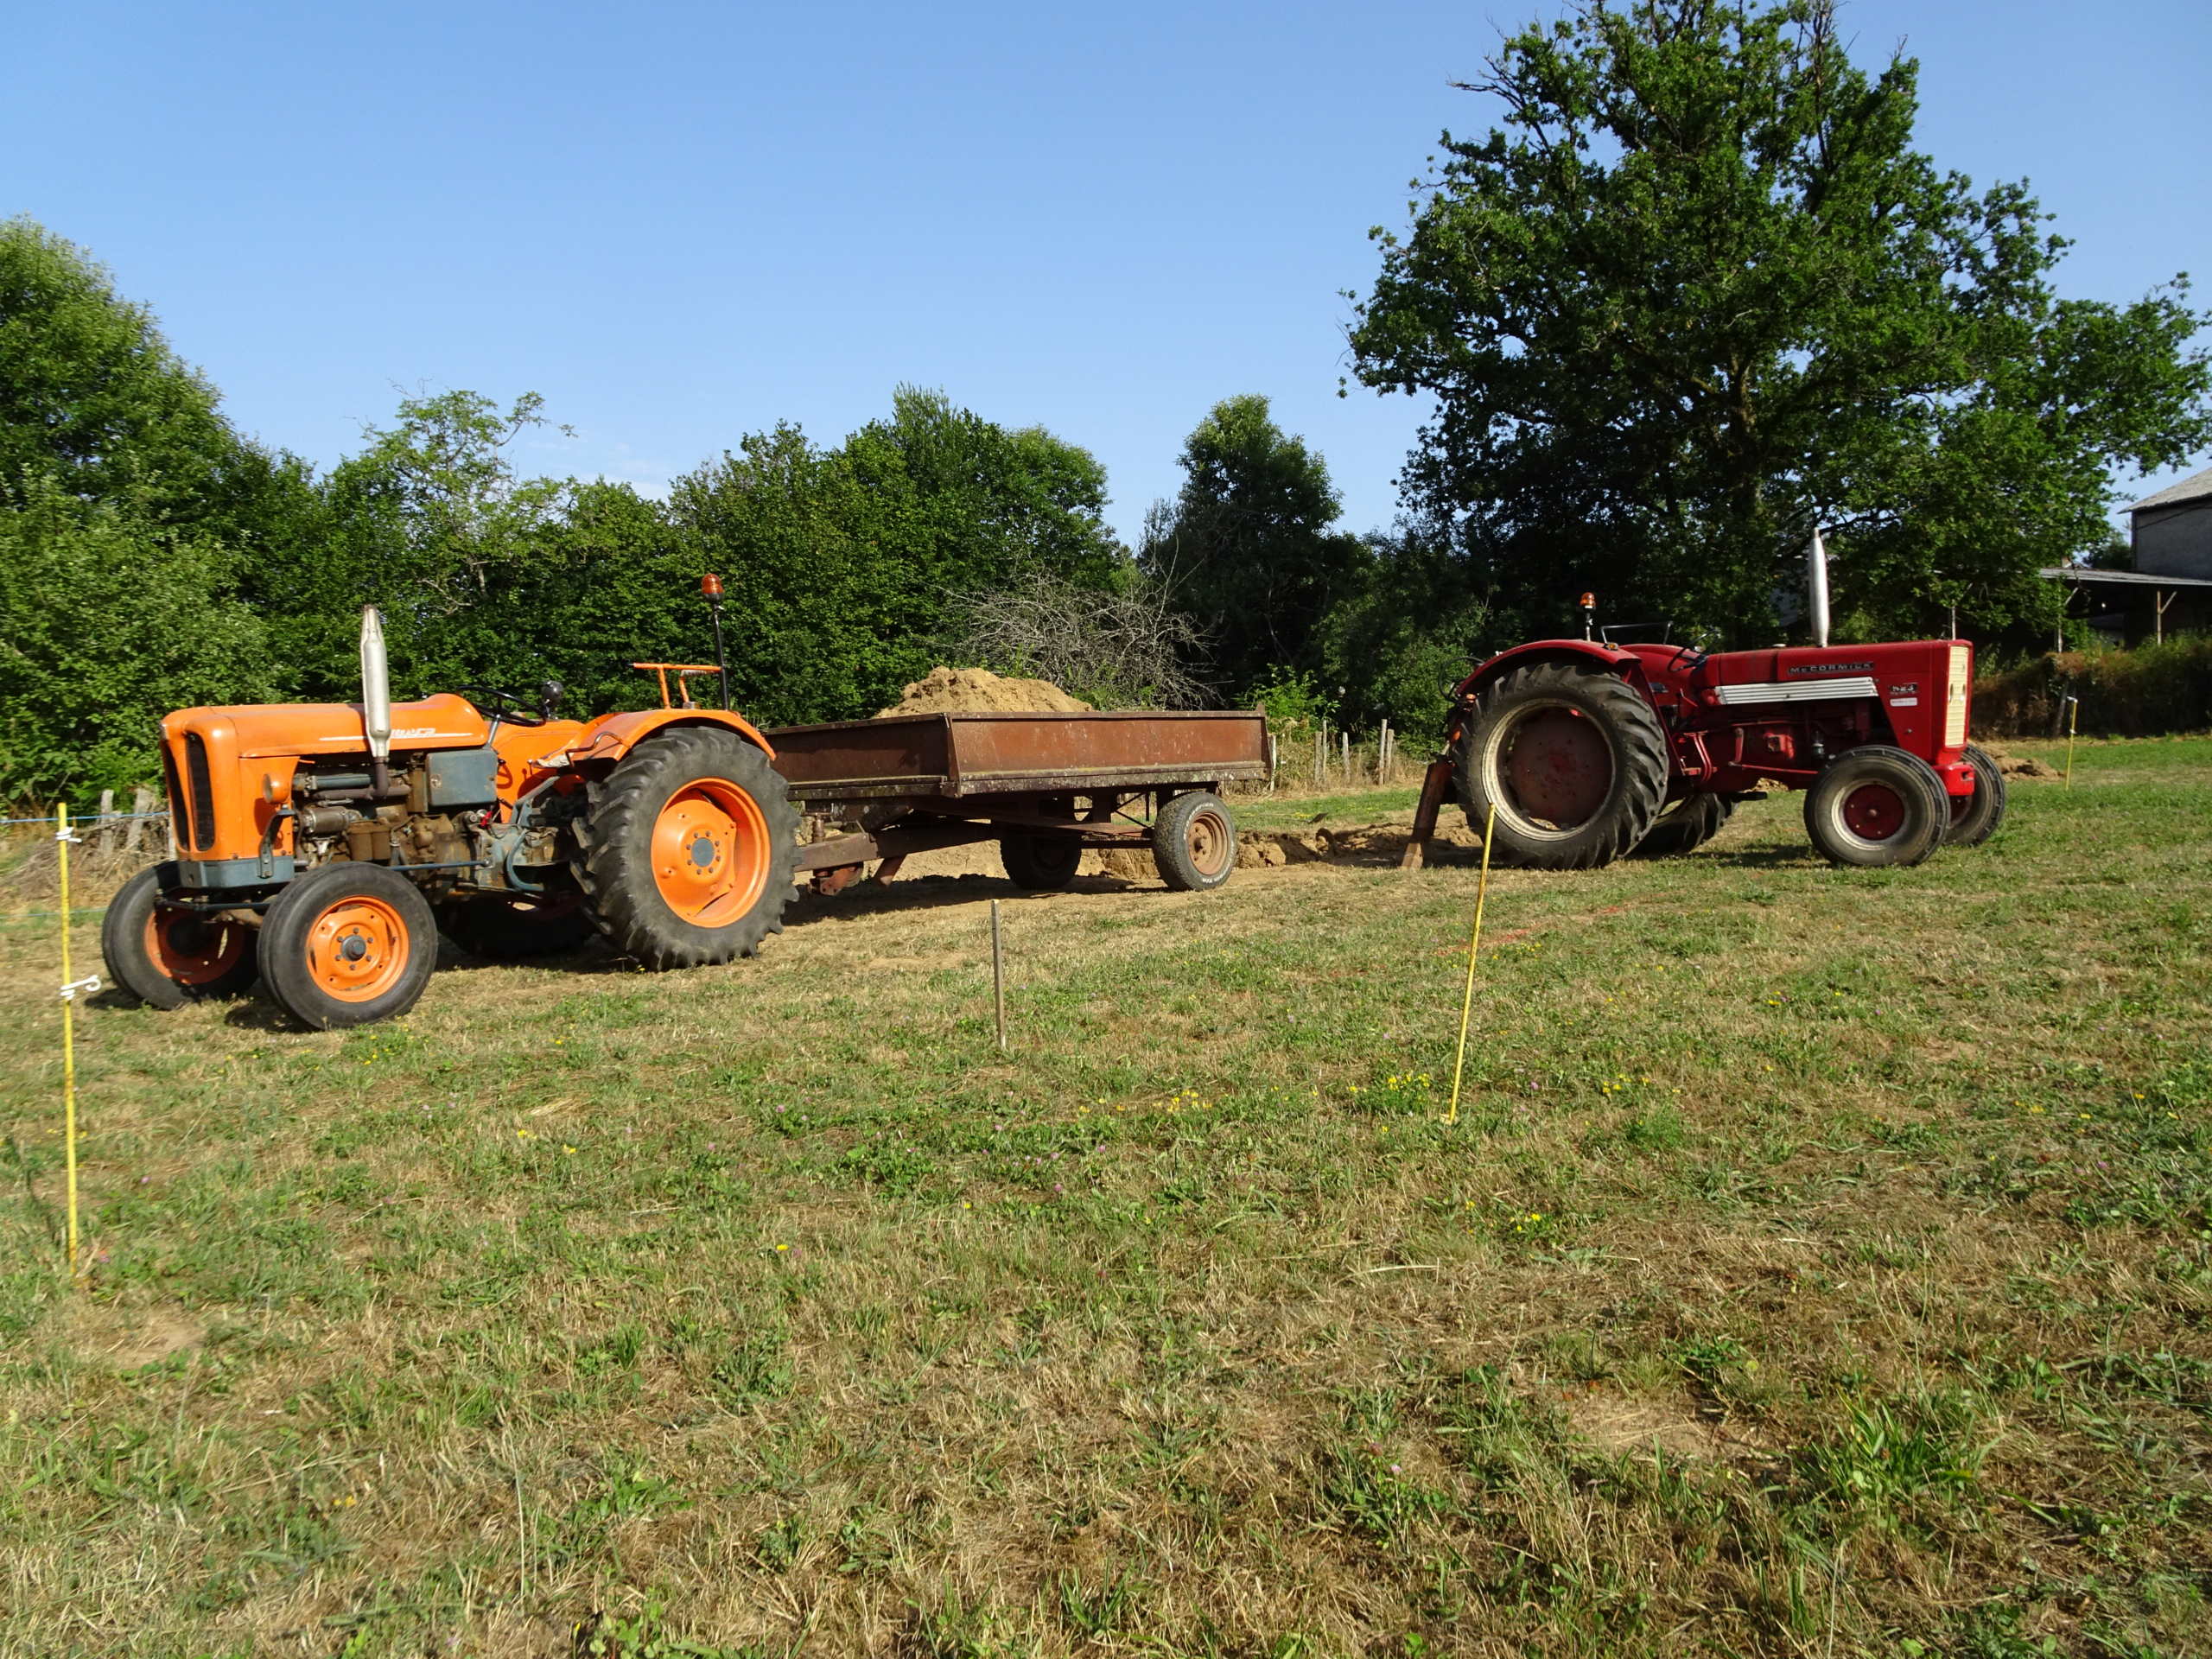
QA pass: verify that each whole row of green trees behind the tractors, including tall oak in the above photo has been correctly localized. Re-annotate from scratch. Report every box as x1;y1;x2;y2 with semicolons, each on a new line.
0;0;2212;801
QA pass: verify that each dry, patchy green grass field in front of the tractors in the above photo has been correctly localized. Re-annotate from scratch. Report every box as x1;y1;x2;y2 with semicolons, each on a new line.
0;739;2212;1659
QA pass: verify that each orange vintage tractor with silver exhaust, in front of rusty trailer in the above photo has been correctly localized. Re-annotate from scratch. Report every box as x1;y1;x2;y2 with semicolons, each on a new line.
99;597;798;1028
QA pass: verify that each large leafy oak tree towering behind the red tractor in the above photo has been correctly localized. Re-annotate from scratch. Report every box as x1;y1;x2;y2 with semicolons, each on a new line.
1351;0;2212;644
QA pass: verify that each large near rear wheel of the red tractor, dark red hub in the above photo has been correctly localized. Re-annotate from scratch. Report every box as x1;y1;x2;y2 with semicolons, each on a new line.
1453;661;1672;869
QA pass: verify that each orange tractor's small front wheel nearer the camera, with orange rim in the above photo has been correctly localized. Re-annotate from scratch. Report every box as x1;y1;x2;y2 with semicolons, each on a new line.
259;858;438;1031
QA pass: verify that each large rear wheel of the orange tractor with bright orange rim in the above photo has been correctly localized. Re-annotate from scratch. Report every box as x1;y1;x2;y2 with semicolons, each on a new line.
575;726;798;969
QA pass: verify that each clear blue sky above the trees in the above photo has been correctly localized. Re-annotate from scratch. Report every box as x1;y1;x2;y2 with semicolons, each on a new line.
0;0;2212;546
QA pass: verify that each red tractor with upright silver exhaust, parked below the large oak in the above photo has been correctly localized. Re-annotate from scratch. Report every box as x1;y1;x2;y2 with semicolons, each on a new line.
1405;595;2004;869
